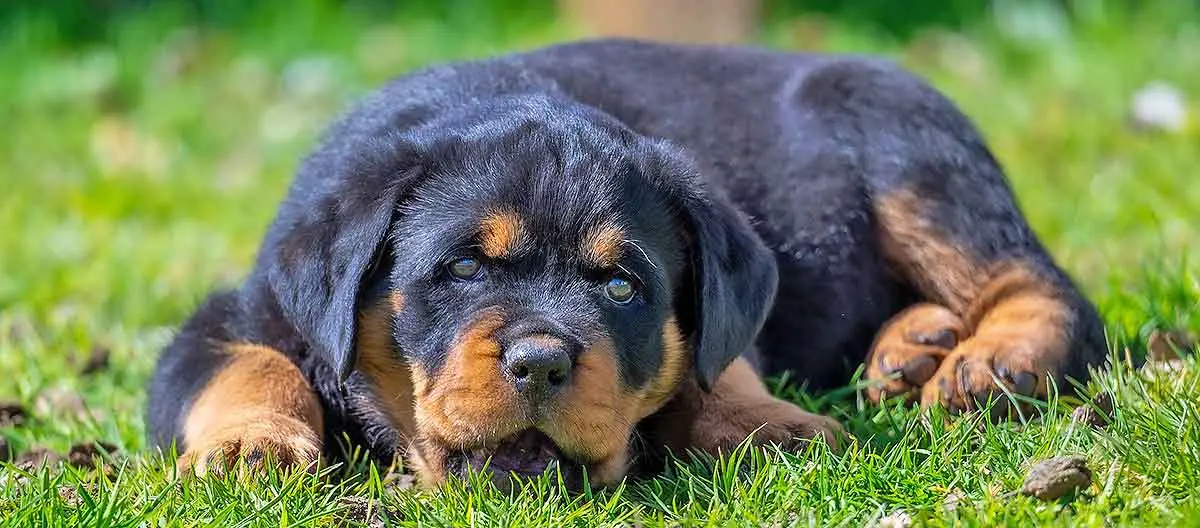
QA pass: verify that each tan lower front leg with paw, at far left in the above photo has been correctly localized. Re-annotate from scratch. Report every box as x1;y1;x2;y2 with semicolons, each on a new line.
178;344;323;475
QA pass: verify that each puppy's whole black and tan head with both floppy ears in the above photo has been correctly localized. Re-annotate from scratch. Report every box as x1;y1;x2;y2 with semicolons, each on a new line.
266;98;776;492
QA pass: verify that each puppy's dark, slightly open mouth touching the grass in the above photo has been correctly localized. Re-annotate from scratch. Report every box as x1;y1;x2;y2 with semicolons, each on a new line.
449;428;582;485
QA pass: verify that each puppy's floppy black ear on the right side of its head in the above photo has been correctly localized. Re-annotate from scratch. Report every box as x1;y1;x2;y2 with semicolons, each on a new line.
656;145;779;390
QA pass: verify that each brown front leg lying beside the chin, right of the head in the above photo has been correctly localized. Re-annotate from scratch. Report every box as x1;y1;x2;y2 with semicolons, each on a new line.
643;358;842;455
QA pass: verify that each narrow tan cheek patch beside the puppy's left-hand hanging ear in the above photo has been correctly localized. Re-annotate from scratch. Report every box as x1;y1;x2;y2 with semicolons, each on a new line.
356;292;415;438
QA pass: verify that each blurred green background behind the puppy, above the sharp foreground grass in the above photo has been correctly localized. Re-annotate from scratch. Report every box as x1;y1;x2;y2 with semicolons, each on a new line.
0;0;1200;362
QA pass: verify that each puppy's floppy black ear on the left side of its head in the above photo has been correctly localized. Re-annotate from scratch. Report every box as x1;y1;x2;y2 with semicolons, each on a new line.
259;137;424;379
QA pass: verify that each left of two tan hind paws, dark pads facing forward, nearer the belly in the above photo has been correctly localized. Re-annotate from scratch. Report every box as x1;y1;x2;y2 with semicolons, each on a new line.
866;304;965;403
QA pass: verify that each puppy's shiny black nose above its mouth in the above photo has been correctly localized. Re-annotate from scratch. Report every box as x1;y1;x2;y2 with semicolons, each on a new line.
504;336;572;402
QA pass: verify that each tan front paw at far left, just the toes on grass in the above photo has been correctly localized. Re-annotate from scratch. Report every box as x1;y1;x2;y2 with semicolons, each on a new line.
176;415;320;476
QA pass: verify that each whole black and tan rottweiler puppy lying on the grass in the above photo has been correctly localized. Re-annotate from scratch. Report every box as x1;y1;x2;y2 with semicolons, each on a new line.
149;41;1105;485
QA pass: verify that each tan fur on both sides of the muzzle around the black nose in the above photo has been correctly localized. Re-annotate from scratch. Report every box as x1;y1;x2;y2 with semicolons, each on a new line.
409;314;690;486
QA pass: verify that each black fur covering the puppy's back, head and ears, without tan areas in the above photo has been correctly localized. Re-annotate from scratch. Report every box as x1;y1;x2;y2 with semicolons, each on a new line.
149;41;1104;480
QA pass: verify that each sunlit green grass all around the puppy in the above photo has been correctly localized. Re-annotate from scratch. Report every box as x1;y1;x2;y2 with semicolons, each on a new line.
0;2;1200;526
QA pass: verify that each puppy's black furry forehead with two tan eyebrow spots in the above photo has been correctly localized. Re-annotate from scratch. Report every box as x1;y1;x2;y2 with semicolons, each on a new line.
397;147;683;270
